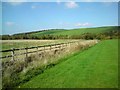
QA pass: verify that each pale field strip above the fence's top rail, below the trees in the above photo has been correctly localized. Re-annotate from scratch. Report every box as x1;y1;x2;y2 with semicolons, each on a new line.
1;39;79;50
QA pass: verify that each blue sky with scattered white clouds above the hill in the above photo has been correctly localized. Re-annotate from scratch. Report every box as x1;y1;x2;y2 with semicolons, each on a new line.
0;0;118;35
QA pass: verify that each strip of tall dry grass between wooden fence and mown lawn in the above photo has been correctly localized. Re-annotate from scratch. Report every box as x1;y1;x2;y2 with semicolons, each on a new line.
2;40;98;88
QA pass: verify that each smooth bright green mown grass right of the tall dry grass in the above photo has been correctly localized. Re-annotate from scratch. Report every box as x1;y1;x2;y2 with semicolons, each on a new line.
20;40;118;88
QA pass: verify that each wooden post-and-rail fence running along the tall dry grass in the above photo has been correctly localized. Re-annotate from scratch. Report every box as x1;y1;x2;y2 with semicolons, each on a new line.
0;41;78;60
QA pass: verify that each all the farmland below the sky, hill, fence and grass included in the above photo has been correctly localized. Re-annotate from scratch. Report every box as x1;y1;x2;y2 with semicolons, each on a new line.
1;26;119;88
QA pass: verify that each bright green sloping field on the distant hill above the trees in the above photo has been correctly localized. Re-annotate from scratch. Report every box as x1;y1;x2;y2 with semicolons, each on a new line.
32;26;117;36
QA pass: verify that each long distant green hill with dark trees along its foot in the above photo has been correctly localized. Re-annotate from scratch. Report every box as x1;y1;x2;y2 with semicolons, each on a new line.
2;26;119;39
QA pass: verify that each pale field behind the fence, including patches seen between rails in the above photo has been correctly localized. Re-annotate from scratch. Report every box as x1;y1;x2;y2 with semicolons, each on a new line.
0;39;79;61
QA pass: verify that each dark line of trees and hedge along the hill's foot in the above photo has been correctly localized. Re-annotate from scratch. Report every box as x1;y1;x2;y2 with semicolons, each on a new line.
0;30;120;40
